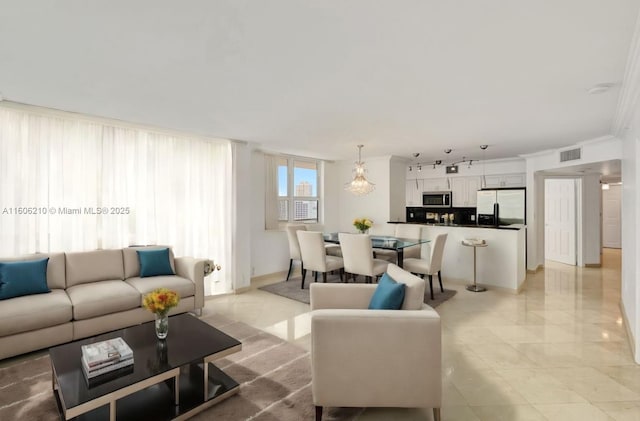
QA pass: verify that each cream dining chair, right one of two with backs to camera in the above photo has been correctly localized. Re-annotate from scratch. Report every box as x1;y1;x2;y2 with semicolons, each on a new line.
338;232;389;283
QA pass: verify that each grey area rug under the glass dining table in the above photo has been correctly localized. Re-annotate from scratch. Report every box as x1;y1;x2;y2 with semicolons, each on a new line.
259;274;457;308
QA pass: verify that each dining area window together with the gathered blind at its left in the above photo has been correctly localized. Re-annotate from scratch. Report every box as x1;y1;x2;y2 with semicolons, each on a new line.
265;156;320;229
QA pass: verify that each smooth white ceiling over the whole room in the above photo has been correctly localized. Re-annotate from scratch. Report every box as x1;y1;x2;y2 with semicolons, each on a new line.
0;0;639;161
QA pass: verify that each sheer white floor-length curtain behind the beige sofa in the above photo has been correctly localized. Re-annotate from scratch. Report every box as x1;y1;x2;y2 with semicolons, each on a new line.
0;107;233;293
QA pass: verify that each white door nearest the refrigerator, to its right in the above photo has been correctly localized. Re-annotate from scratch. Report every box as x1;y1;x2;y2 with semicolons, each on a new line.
544;179;576;265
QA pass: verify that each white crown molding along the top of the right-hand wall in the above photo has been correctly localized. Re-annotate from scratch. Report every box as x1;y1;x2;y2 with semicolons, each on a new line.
611;9;640;137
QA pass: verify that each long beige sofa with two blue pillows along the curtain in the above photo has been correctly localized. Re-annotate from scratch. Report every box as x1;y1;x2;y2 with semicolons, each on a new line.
0;246;206;359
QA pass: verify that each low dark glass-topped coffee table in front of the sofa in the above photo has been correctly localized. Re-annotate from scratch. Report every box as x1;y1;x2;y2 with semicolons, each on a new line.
49;314;242;420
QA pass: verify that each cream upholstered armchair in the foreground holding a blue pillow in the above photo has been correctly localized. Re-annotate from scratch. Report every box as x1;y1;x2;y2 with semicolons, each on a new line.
310;264;442;421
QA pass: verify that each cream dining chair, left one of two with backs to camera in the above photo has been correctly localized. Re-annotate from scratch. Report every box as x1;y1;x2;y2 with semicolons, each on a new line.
297;231;344;289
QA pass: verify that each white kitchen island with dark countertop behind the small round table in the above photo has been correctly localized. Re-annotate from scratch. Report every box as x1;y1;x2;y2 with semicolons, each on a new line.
388;222;526;292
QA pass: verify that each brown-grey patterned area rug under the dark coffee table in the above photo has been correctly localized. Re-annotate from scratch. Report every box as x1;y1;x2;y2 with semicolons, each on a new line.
0;315;362;421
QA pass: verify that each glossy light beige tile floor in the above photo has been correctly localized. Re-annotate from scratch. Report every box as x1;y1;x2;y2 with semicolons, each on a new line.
205;249;640;421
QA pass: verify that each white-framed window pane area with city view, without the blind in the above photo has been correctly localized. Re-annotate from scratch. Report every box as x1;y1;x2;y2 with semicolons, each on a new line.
278;157;319;222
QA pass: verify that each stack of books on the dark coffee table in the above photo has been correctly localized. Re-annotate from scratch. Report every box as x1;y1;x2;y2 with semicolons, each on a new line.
81;338;133;381
